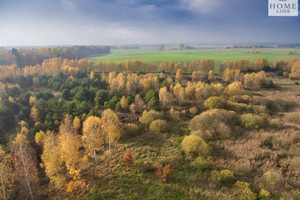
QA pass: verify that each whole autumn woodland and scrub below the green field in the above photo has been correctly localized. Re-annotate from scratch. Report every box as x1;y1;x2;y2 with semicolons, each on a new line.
0;48;300;200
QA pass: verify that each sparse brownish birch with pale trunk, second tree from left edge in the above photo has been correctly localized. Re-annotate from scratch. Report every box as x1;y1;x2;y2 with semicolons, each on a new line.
12;133;38;199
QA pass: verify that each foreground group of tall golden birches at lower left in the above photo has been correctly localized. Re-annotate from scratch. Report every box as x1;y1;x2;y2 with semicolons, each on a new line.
0;109;122;199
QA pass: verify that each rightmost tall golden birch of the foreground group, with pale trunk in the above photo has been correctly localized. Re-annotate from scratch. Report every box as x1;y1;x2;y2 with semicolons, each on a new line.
101;109;121;153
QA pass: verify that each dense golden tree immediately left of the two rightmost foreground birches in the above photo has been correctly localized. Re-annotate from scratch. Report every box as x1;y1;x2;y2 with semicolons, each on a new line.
58;114;81;177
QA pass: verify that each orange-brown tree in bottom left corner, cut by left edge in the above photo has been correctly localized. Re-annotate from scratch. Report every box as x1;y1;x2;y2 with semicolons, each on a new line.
0;147;14;200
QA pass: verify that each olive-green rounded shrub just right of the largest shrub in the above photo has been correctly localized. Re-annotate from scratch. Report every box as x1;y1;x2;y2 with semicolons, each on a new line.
241;114;266;130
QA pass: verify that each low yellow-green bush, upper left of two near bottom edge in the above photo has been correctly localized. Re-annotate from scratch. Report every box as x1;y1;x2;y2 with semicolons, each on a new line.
211;169;234;186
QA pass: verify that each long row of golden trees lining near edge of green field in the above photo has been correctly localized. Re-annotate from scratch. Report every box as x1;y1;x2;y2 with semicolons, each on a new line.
0;57;299;82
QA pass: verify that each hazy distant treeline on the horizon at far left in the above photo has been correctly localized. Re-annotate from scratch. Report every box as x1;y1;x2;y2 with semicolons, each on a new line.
0;45;110;68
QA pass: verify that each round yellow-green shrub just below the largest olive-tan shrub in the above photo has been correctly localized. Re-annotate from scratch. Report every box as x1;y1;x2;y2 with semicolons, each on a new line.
181;135;210;156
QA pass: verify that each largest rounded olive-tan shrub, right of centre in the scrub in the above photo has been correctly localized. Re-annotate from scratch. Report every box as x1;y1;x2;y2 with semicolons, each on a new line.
189;109;238;137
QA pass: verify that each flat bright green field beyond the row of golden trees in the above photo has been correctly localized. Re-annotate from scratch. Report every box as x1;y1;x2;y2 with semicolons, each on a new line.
88;48;300;64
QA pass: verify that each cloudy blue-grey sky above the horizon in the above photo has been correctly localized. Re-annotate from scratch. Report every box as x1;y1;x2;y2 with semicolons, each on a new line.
0;0;300;46
